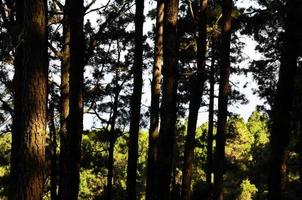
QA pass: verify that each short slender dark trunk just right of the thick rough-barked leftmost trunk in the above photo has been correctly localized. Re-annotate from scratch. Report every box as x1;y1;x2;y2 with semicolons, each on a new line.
48;85;58;200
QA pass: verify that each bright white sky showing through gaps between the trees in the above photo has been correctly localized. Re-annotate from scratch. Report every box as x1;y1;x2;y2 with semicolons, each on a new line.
84;0;263;129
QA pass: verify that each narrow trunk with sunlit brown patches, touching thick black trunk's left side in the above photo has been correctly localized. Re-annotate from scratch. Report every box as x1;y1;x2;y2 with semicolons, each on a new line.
59;0;70;199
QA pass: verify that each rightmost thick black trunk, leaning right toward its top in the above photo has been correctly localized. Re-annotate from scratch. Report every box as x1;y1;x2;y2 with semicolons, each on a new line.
268;0;301;200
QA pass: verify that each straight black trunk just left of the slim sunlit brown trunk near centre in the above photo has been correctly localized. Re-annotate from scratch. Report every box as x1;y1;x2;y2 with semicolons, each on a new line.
127;0;144;200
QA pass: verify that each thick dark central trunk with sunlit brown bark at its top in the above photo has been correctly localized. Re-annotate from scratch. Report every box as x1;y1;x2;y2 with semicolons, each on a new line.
156;0;178;200
